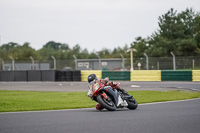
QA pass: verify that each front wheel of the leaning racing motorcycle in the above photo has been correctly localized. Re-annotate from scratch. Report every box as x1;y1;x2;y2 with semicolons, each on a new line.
97;95;117;111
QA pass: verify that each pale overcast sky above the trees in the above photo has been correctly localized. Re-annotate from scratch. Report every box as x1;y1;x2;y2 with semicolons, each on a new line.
0;0;200;52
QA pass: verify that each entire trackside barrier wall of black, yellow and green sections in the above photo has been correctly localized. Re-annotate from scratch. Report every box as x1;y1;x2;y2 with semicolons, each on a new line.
0;70;200;82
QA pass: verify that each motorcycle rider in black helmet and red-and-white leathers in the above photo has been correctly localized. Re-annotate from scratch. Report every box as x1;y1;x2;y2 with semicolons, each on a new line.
87;74;127;110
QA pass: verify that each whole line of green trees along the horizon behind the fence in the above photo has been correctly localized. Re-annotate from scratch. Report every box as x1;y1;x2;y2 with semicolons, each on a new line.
0;8;200;60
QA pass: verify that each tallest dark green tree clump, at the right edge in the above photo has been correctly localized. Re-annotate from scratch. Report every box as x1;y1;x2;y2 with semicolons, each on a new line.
148;9;200;56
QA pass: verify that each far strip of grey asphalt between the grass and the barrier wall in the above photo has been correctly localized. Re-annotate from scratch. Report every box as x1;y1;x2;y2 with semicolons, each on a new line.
0;81;200;92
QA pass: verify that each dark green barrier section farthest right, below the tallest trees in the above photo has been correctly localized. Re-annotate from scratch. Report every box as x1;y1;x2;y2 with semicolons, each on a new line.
161;70;192;81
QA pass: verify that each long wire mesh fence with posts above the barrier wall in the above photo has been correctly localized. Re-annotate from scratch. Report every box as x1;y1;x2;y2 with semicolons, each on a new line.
0;56;200;71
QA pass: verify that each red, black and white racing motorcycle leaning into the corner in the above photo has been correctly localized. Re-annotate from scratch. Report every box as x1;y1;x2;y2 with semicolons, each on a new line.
92;82;138;111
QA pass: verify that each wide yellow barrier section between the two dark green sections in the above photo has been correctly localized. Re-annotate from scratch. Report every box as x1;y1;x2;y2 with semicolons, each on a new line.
131;70;161;81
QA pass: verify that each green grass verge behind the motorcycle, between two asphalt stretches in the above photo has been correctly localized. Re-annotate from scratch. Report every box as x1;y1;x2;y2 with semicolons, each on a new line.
0;90;200;112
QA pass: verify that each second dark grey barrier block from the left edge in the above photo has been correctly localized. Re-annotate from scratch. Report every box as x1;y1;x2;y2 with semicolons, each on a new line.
14;71;28;81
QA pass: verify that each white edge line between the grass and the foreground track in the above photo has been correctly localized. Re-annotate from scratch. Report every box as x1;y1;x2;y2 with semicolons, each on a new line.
0;98;200;115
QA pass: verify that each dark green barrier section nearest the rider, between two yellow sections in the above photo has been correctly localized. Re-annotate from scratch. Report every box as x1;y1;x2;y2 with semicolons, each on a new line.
102;71;130;81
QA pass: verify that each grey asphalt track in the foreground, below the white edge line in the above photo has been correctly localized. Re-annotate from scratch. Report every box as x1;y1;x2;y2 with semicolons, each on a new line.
0;99;200;133
